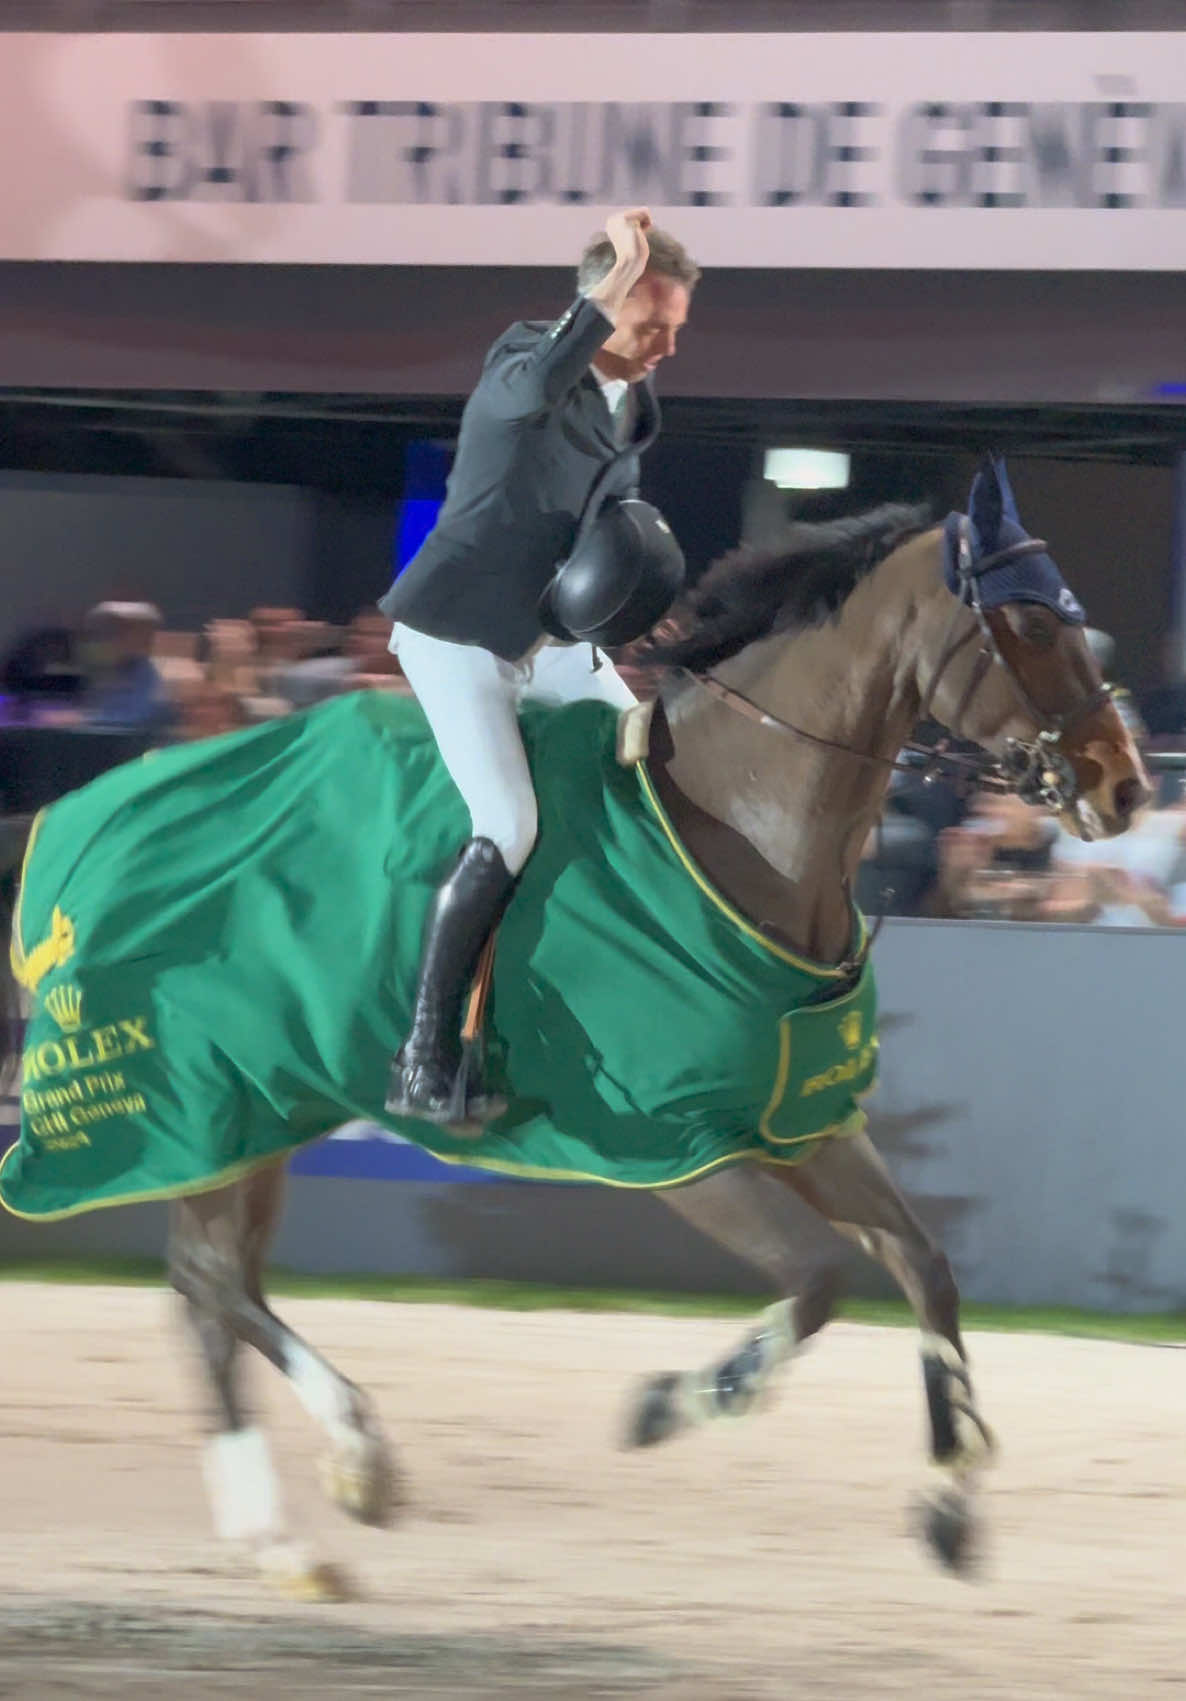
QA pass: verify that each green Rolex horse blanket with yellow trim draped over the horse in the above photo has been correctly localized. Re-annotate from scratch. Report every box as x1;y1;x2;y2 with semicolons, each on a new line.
0;692;876;1218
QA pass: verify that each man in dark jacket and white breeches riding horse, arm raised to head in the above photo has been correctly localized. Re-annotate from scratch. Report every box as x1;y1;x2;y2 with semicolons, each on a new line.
379;208;699;1123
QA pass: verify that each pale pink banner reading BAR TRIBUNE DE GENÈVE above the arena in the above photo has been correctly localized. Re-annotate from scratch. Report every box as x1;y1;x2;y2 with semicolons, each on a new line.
0;32;1186;270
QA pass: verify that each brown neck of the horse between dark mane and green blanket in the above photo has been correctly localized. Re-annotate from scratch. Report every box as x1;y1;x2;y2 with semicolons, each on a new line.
664;539;936;963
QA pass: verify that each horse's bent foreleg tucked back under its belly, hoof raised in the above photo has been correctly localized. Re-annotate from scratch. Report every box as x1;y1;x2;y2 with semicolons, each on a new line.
626;1165;837;1448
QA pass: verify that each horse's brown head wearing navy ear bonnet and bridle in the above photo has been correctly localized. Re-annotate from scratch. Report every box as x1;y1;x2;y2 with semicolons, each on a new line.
922;456;1152;839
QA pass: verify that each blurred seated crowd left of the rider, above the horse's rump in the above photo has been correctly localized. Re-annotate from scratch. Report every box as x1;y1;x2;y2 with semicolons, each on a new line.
2;602;407;740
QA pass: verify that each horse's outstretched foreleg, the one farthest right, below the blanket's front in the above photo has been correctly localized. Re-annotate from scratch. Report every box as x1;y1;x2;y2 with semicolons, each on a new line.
773;1135;995;1568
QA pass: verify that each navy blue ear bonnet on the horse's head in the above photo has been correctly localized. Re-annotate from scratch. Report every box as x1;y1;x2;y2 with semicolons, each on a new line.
943;456;1087;626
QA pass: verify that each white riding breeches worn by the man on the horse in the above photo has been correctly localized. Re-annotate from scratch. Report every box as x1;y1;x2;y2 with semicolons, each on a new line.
390;626;636;874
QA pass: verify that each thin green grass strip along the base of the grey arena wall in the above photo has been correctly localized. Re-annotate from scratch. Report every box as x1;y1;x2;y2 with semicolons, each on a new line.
0;1259;1186;1344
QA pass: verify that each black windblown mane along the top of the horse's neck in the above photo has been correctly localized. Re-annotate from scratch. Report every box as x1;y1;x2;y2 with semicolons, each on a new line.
631;502;931;672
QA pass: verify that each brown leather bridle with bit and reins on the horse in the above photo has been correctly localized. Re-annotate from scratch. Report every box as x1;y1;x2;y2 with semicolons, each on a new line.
681;514;1111;811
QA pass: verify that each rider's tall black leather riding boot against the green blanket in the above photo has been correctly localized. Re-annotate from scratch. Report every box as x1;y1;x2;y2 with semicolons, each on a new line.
386;839;514;1124
